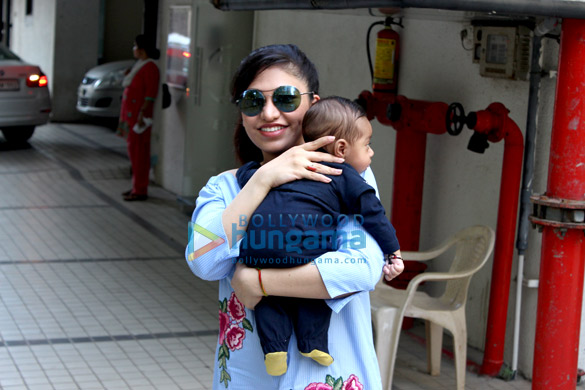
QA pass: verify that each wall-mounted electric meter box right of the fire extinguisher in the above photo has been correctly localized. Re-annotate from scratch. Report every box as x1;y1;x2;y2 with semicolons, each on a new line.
473;26;530;80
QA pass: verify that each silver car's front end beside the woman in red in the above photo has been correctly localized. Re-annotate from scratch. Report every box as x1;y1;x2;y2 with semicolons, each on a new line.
77;60;135;117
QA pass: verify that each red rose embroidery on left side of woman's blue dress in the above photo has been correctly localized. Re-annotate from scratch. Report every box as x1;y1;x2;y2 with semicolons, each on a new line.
217;292;254;388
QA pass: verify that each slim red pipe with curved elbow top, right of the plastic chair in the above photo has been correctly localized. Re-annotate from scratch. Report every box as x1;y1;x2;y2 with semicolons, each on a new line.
473;103;524;376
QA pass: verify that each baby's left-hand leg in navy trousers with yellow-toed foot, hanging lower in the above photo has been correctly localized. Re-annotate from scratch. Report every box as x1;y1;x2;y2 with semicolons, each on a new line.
254;296;293;376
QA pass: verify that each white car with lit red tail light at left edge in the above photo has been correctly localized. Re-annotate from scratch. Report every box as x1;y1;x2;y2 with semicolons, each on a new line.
0;46;51;143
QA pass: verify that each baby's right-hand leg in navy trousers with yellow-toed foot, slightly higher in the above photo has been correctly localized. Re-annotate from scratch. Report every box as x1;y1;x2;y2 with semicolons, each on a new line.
293;298;333;366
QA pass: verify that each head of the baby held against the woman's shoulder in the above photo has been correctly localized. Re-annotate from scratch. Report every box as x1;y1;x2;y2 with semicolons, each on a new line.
303;96;374;173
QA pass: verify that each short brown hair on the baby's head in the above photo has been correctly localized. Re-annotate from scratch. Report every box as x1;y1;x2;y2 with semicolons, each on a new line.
303;96;366;143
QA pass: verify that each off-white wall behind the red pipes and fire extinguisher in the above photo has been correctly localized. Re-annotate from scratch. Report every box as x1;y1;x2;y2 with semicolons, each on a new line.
254;11;557;377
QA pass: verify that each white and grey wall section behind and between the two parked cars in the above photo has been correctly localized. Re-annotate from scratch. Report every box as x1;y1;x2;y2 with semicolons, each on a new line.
10;0;99;121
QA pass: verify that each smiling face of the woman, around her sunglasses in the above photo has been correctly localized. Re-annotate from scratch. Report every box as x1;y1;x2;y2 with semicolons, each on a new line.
241;66;319;162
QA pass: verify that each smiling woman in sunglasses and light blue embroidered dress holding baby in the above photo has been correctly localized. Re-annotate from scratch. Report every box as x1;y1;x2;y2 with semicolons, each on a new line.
186;45;403;390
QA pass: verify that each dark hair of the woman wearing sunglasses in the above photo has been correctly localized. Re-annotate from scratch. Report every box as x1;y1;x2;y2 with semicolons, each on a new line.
231;45;319;163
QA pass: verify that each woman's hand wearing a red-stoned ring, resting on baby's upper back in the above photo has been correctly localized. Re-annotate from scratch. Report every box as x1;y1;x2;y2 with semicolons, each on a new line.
253;136;344;189
